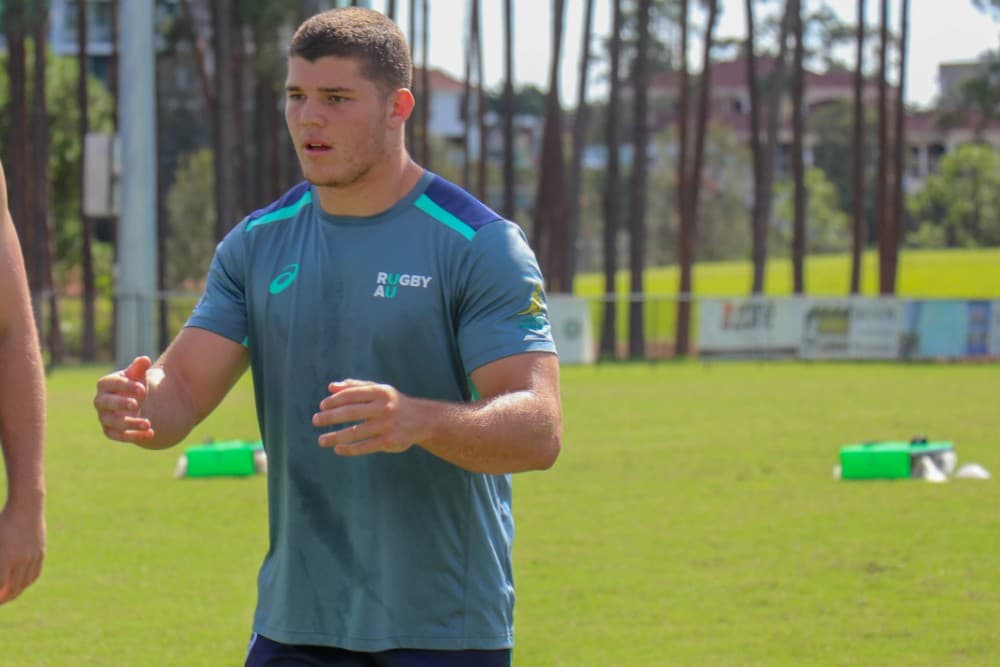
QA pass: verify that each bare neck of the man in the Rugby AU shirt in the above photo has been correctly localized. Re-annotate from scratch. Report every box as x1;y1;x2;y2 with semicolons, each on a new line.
316;153;424;218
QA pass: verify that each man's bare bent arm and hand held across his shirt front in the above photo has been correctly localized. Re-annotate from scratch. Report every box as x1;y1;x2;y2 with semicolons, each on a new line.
313;352;562;474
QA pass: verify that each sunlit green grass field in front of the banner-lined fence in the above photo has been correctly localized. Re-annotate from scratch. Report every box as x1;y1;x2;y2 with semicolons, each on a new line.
0;362;1000;667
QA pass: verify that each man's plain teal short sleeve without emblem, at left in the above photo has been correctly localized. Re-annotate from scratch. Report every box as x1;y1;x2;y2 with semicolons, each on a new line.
185;225;249;345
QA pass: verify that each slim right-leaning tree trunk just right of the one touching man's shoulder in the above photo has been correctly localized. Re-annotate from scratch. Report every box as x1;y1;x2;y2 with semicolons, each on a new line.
562;0;594;293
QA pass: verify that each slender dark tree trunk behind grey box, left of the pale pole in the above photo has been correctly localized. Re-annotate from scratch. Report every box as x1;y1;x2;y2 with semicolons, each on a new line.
76;0;96;361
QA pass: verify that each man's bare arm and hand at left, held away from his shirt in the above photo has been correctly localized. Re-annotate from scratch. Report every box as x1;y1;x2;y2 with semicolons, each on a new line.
94;327;247;449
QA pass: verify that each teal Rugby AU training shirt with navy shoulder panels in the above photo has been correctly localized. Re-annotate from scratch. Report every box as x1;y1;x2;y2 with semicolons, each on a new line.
187;172;555;651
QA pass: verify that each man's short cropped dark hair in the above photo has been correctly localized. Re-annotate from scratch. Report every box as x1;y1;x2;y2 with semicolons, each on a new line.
288;7;413;94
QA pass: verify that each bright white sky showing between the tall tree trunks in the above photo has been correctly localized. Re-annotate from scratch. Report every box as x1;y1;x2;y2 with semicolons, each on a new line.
362;0;1000;107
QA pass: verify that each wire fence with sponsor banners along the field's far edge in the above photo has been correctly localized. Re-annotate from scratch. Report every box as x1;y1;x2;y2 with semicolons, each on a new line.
34;291;1000;367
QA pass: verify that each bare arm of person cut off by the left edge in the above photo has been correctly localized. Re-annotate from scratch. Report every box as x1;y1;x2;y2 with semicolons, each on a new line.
0;159;45;604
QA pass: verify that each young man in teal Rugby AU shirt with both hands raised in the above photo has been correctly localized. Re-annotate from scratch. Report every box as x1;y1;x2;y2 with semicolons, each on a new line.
95;8;562;666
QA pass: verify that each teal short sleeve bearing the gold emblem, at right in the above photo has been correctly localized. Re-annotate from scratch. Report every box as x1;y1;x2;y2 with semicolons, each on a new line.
458;220;556;373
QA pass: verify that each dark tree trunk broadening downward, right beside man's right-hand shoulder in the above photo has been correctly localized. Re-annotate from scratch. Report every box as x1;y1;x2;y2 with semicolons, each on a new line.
531;0;567;292
